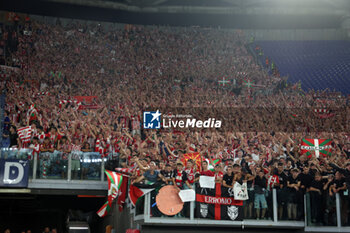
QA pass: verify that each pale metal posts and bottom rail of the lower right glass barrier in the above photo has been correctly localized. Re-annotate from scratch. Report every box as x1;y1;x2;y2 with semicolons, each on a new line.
129;189;350;232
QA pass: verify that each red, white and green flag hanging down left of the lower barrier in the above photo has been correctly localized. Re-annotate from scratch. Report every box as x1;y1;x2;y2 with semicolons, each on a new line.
97;170;123;217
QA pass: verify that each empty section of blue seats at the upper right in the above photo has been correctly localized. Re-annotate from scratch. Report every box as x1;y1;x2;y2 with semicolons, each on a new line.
253;41;350;94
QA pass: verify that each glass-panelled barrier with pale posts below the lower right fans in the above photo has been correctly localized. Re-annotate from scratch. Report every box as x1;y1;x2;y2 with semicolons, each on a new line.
129;184;350;232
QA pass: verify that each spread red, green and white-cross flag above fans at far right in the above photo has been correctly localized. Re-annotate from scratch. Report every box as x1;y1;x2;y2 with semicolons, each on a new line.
300;138;332;158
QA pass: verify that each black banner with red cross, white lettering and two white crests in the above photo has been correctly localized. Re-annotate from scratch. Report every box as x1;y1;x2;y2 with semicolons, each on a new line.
196;183;243;221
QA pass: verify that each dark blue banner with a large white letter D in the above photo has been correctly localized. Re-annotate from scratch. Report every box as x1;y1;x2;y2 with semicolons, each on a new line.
0;159;29;188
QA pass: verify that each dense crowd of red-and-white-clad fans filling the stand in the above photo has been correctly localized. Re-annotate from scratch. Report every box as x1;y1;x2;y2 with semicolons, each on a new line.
1;13;350;225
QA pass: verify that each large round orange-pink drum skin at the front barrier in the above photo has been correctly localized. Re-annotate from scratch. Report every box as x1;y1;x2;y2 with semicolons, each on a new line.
156;185;184;216
